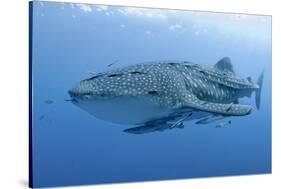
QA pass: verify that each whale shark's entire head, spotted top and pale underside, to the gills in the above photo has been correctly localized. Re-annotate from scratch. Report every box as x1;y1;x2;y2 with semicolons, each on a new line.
68;69;171;124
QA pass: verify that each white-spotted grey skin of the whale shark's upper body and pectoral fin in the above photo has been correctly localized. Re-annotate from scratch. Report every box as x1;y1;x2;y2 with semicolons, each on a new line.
69;58;259;116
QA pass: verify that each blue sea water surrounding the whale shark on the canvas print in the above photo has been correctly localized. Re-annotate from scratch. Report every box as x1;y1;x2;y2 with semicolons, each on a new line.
32;1;272;187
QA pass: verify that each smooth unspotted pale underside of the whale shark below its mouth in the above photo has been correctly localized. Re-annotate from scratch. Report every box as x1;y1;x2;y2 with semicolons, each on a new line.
73;96;172;124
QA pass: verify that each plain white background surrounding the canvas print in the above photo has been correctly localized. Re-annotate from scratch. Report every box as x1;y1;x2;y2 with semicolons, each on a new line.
0;0;281;189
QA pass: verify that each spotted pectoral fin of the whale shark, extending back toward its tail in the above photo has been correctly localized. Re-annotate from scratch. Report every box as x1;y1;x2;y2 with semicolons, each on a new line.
184;94;252;116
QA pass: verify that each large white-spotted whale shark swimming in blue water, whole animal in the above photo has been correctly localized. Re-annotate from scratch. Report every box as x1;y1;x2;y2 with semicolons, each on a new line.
68;57;264;134
